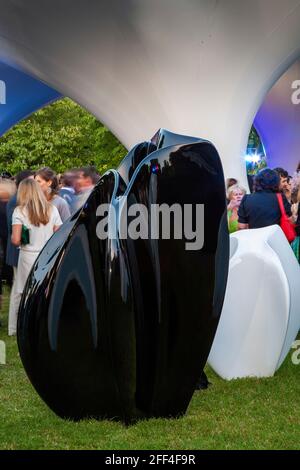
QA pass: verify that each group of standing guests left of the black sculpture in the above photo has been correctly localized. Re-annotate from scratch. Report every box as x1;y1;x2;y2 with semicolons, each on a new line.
0;167;100;336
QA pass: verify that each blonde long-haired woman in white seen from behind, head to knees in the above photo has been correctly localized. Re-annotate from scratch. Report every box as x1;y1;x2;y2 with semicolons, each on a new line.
11;179;62;294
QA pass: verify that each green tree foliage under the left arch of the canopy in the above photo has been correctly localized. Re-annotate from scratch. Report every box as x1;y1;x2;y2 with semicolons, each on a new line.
0;98;127;174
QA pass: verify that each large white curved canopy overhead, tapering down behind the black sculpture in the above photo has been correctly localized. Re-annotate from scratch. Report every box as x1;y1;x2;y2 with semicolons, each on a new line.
0;0;300;184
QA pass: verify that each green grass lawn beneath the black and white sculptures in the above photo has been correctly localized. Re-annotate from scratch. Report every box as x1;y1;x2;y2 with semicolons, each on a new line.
0;284;300;450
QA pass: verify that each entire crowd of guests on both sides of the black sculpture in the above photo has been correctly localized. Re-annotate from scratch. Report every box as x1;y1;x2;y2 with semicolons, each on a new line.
0;164;300;335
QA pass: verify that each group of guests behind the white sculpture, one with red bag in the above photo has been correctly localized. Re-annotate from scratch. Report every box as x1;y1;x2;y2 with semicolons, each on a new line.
226;163;300;262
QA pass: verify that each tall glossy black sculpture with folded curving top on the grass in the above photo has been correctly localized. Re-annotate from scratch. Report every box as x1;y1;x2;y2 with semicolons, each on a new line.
18;130;229;421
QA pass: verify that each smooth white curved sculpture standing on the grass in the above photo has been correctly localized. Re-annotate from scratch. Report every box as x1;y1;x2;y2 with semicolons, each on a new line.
208;225;300;380
